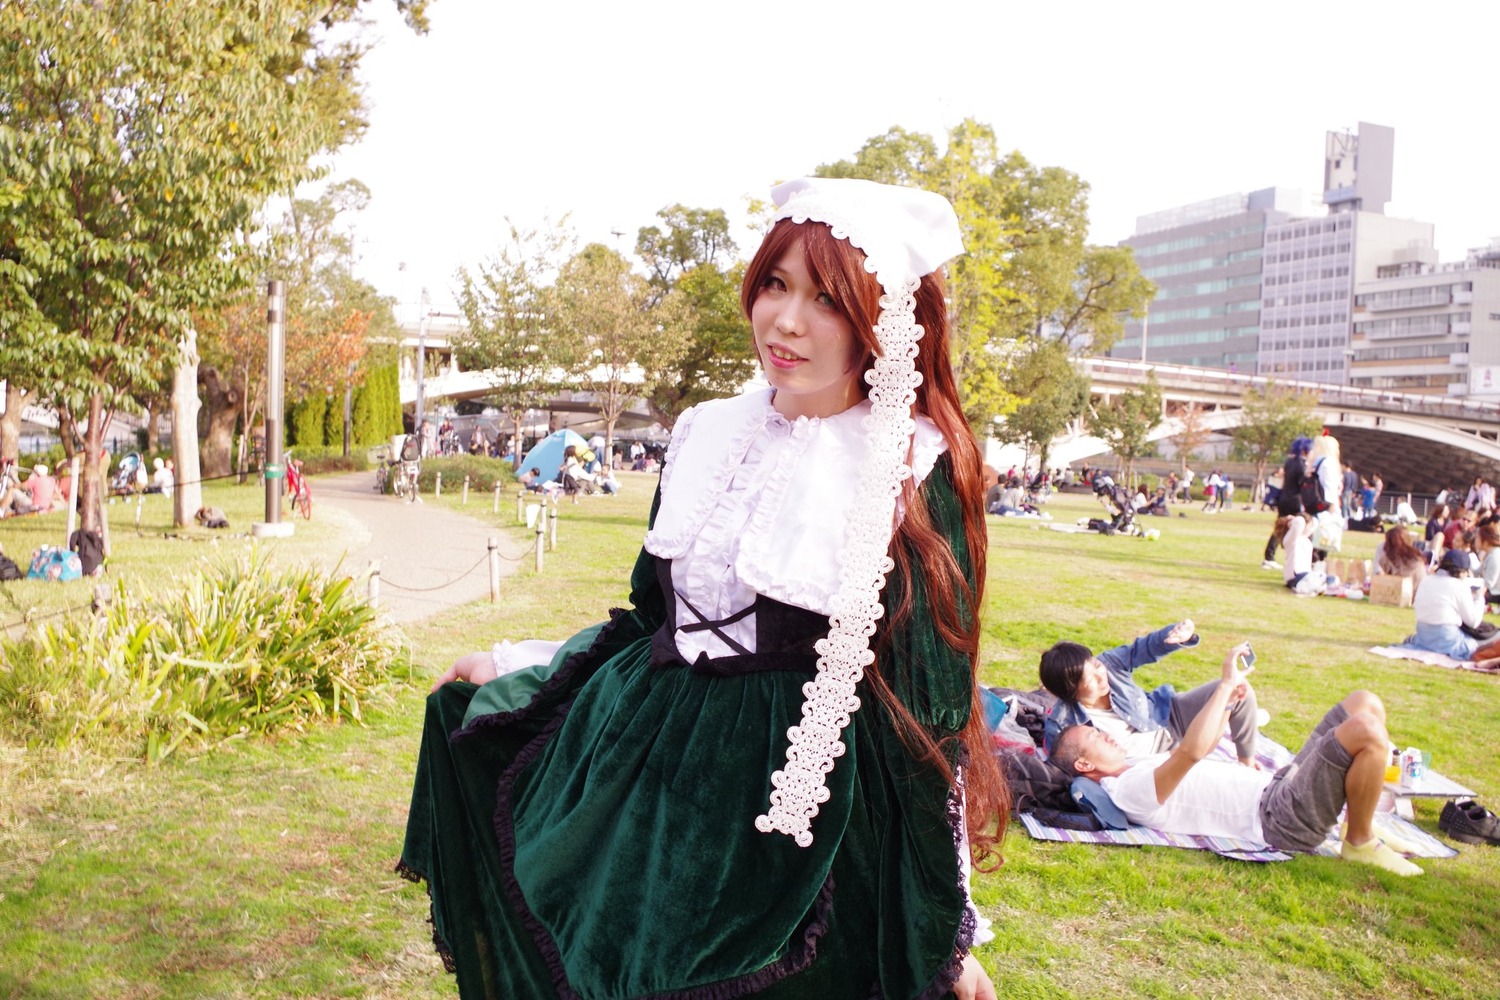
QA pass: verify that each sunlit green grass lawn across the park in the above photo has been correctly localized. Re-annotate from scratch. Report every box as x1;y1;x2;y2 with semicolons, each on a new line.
0;474;1500;999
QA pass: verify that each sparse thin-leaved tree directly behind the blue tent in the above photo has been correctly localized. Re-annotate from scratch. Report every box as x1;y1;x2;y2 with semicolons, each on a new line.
453;219;573;469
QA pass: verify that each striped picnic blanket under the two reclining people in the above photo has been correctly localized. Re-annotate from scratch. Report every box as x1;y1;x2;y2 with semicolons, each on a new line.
1020;735;1458;862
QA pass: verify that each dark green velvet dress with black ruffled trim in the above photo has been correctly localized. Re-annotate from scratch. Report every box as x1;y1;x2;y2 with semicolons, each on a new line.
399;457;974;1000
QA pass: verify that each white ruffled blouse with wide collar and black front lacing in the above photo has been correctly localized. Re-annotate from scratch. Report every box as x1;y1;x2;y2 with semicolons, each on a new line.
645;390;948;663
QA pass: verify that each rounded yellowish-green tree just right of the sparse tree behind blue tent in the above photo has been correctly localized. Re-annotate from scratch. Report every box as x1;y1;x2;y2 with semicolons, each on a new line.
552;243;687;462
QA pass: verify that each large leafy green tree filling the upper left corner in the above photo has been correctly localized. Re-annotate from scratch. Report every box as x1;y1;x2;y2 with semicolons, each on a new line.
0;0;423;528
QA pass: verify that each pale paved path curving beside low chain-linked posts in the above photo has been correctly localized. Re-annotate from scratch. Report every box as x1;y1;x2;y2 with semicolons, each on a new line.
312;472;527;622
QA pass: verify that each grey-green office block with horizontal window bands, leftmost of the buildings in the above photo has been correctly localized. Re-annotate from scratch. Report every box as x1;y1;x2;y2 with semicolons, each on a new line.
1110;187;1305;372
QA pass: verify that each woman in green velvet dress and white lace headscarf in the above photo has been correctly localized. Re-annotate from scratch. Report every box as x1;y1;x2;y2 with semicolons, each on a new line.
401;178;1005;1000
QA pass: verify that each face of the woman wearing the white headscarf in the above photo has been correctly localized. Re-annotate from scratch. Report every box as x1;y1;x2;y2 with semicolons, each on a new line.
750;244;864;418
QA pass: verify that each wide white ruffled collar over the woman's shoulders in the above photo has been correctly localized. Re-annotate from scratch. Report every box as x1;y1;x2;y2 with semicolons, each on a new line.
645;390;948;615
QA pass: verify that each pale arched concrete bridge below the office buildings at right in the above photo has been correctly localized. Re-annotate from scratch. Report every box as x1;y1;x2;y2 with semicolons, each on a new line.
1053;358;1500;493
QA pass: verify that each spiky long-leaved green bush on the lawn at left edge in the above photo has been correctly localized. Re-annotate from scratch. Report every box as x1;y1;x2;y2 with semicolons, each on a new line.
0;555;398;763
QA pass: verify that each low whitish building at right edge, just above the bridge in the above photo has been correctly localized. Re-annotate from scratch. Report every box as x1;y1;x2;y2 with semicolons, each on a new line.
1350;241;1500;397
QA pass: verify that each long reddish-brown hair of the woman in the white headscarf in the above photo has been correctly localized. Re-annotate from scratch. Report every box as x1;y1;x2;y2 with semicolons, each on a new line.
740;219;1010;870
